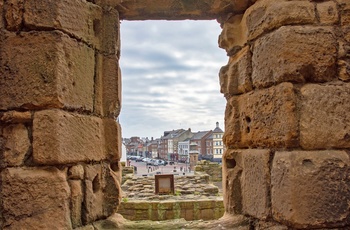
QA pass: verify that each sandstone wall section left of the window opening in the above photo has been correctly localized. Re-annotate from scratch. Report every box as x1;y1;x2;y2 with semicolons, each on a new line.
0;0;121;229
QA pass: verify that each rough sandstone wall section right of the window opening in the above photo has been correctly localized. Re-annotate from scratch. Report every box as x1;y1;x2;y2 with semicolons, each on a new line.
219;0;350;229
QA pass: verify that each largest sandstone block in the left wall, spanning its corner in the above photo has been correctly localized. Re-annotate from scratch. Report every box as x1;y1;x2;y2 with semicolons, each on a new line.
0;31;94;110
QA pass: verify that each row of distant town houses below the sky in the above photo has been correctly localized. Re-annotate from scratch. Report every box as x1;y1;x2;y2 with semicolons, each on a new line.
123;122;224;162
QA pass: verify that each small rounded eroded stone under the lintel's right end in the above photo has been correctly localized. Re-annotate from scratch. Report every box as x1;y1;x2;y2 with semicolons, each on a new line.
219;15;247;56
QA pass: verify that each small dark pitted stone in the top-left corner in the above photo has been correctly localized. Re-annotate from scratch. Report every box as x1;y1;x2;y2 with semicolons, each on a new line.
0;0;24;31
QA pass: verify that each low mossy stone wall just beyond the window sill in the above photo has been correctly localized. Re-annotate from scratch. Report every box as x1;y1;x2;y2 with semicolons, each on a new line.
118;197;225;221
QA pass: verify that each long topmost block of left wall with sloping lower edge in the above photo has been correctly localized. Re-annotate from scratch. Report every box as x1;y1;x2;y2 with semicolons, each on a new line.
23;0;102;47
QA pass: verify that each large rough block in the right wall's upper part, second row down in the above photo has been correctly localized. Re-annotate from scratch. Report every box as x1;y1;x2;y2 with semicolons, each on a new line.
252;26;337;88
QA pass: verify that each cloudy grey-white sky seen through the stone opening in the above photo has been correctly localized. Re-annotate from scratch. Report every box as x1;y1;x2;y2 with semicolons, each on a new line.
119;20;228;138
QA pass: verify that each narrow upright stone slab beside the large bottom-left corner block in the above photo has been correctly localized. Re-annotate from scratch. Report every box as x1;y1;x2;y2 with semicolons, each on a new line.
68;180;84;228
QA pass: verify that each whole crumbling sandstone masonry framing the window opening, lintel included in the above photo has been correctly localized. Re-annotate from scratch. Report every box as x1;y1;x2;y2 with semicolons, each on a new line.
0;0;350;229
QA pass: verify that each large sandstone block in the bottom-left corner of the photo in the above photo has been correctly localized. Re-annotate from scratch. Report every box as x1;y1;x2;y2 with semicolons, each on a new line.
1;167;72;229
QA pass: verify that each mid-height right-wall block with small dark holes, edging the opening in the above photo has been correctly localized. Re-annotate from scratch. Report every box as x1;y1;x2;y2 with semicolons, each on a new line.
224;83;298;147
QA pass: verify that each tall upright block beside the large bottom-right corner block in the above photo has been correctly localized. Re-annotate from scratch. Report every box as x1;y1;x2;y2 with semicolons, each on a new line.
242;149;270;220
